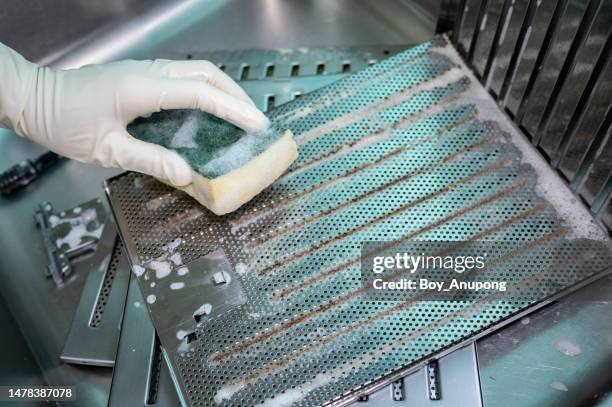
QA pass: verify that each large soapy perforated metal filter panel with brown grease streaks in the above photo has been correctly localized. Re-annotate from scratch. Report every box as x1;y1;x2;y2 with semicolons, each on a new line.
107;38;612;406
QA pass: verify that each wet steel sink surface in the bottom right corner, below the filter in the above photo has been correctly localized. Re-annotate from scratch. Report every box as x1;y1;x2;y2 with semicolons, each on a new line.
477;277;612;407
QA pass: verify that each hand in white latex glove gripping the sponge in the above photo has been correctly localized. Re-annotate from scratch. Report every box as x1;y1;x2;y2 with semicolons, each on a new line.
0;43;268;186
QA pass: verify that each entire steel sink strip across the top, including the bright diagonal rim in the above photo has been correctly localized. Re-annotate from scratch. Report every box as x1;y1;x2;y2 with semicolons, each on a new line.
0;0;438;67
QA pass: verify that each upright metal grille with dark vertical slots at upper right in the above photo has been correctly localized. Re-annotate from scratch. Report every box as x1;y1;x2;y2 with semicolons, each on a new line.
443;0;612;231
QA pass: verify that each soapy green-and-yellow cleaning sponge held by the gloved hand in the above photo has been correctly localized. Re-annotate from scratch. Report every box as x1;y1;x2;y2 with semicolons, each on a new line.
128;110;297;215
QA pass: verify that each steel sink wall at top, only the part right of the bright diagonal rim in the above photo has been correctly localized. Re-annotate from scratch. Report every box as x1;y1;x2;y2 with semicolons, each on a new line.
126;0;438;58
